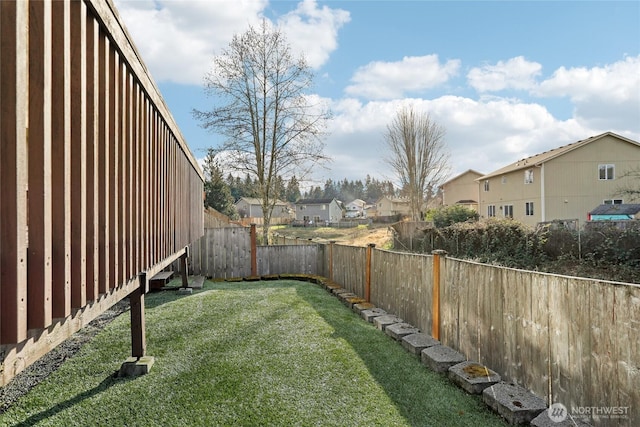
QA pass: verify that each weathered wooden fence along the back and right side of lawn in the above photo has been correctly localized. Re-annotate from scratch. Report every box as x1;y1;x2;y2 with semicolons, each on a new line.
196;227;640;426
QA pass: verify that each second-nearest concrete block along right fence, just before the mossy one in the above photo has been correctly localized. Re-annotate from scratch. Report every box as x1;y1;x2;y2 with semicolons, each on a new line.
482;383;557;426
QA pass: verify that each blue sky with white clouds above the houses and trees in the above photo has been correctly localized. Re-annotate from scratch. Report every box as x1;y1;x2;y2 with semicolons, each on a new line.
115;0;640;189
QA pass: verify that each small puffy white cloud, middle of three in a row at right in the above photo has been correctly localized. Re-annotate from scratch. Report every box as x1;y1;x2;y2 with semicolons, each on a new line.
467;56;542;92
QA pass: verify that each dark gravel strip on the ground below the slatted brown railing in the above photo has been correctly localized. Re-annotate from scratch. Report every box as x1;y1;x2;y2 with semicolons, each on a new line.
0;298;129;414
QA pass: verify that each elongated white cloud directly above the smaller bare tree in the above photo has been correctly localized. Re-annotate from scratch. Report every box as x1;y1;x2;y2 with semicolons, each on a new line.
345;55;460;99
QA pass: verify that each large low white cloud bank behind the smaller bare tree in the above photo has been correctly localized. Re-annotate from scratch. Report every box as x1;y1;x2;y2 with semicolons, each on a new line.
325;96;601;179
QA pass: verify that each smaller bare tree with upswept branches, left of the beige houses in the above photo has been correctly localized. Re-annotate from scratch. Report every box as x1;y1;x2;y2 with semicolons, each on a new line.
385;106;449;221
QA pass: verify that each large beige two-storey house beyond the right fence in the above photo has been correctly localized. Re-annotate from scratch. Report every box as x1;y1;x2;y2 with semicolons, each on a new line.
477;132;640;226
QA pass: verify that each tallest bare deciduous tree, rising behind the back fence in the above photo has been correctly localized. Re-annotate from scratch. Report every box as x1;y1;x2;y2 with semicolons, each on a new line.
193;20;330;244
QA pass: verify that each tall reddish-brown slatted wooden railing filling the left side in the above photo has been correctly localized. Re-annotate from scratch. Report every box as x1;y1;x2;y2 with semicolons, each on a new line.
0;0;203;384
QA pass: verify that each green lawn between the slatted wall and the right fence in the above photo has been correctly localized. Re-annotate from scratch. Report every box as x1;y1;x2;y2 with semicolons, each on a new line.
0;280;506;427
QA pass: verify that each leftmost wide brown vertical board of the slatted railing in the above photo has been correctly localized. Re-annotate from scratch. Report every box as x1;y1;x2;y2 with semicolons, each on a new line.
0;2;29;343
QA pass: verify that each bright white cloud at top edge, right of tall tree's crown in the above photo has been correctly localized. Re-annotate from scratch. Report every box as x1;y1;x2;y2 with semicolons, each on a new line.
278;0;351;68
